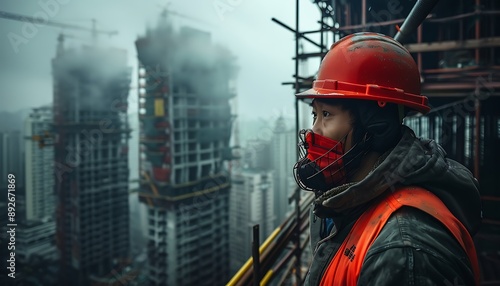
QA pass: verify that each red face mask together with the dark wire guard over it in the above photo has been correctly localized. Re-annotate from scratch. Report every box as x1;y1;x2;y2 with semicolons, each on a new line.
294;130;347;191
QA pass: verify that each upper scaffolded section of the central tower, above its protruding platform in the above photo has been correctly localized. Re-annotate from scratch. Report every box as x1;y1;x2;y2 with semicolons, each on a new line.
136;20;236;203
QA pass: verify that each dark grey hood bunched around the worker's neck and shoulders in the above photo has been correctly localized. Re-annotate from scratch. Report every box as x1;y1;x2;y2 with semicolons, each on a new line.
315;126;482;235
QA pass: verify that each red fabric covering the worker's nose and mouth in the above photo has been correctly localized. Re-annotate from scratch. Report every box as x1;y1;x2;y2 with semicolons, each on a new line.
305;132;346;186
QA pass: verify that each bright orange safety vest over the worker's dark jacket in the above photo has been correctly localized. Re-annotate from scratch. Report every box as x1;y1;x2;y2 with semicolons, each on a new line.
320;186;479;286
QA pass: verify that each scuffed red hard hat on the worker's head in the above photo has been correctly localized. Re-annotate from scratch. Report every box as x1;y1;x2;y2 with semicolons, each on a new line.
296;32;430;113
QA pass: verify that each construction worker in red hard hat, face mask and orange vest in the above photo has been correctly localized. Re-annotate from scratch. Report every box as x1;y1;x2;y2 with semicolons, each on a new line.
294;33;481;286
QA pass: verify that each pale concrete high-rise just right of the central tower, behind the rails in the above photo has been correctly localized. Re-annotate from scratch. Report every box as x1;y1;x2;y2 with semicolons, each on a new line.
229;169;275;274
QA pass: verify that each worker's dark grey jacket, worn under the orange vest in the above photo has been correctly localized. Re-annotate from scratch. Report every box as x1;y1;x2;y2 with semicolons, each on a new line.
305;127;481;286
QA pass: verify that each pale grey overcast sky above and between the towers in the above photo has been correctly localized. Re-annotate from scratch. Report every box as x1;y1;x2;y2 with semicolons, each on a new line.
0;0;319;119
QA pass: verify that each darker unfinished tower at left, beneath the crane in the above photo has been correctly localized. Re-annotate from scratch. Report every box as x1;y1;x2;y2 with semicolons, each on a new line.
52;36;131;285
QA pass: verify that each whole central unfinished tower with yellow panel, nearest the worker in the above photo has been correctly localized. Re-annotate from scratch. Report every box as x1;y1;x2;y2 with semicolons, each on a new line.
136;12;236;285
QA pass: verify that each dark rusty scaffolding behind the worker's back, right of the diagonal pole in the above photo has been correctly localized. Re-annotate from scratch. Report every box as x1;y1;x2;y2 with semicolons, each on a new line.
396;0;500;285
